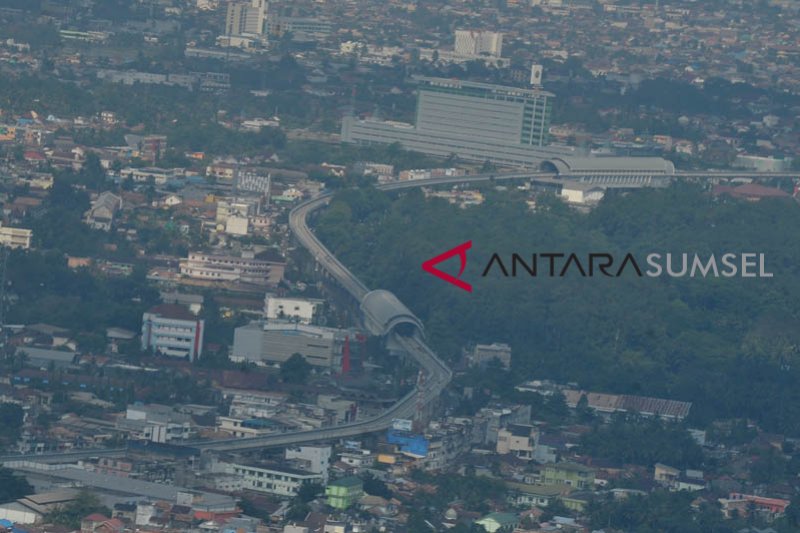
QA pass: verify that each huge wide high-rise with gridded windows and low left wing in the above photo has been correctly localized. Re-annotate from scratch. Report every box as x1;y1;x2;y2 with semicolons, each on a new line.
342;77;571;167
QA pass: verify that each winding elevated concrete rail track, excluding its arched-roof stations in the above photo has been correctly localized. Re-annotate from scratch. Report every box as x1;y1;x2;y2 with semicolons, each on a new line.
0;171;800;462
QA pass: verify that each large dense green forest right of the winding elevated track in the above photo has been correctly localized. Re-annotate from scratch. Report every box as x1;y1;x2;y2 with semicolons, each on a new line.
317;184;800;434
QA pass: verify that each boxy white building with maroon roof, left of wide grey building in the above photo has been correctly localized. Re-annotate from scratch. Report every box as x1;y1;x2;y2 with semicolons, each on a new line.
142;304;205;361
